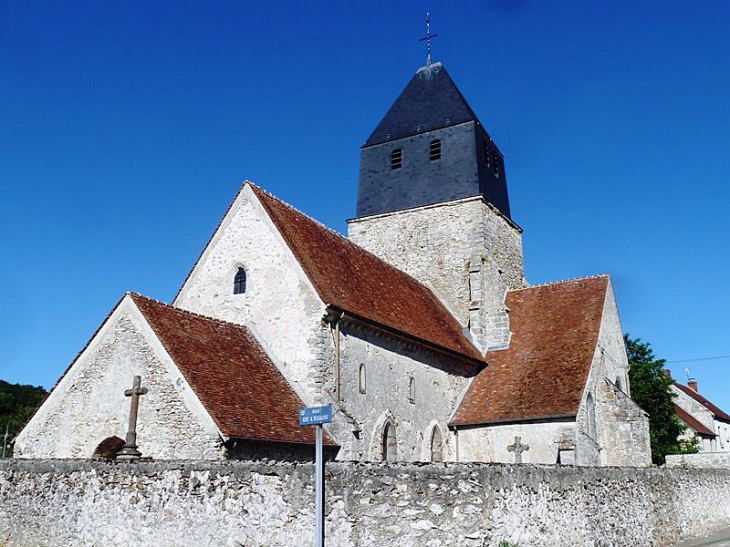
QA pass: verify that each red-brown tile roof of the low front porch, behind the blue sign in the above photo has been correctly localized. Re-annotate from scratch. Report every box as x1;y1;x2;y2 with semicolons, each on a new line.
130;293;334;445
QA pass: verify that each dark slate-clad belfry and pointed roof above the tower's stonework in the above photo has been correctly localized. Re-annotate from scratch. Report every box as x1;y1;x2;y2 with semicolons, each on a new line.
357;63;510;217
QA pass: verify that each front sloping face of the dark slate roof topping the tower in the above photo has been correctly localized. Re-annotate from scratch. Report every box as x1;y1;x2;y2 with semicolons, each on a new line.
365;63;478;146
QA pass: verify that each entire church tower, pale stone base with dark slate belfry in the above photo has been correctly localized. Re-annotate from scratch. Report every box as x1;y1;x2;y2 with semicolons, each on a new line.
348;63;526;352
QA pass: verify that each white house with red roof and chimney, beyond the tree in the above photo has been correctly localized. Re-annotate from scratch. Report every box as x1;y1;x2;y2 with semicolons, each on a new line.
672;378;730;452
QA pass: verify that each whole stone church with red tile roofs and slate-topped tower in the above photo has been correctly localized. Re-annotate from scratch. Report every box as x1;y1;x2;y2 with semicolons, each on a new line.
15;63;650;466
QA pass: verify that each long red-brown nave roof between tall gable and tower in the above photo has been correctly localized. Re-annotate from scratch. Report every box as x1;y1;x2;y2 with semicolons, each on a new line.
251;184;483;366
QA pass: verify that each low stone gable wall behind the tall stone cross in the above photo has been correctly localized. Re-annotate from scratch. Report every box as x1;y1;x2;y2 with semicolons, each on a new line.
13;305;223;460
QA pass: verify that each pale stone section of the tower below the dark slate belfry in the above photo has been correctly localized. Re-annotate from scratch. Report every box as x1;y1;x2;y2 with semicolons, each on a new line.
348;196;526;351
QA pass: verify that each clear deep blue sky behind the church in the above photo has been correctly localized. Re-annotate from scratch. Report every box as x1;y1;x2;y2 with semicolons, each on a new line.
0;0;730;410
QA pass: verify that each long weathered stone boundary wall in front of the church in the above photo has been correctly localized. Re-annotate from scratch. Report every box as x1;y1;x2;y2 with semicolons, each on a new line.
0;460;730;547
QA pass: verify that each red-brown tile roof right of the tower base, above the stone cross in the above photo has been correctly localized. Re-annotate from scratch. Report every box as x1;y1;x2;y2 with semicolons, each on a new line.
452;276;608;425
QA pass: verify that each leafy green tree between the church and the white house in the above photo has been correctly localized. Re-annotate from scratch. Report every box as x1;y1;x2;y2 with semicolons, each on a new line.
624;334;697;465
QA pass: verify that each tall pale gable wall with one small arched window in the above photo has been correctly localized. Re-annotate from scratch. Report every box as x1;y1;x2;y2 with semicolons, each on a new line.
173;187;324;405
